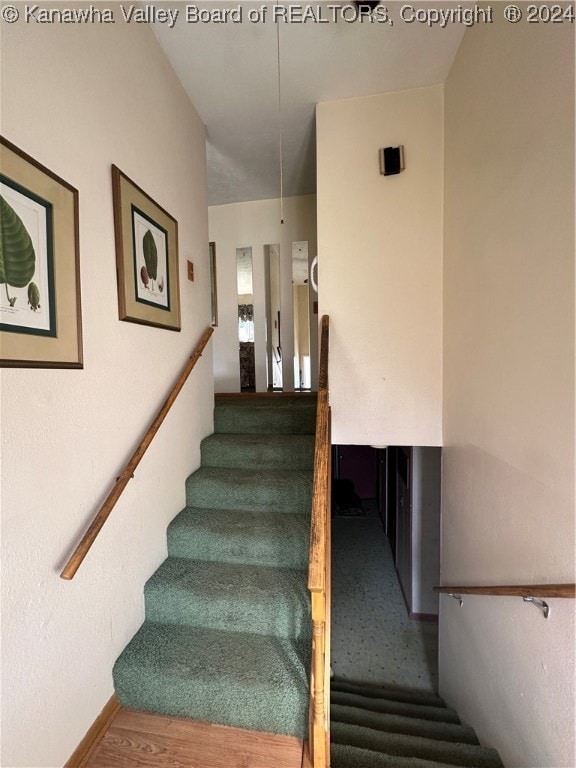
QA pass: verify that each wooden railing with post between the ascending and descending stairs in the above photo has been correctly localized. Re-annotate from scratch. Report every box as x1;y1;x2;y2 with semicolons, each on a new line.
307;315;332;768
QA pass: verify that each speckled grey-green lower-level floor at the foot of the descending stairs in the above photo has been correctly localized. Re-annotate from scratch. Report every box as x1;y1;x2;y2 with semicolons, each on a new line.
332;502;438;691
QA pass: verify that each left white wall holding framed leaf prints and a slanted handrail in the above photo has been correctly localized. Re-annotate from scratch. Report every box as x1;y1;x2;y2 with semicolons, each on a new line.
1;10;213;768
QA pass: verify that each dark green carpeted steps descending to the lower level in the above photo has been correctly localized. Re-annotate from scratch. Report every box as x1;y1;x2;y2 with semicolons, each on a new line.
330;680;502;768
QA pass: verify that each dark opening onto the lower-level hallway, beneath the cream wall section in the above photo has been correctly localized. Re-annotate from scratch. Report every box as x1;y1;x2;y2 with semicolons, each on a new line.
332;445;441;691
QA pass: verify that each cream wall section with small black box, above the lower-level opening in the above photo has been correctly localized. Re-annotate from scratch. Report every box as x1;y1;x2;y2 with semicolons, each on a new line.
316;86;443;445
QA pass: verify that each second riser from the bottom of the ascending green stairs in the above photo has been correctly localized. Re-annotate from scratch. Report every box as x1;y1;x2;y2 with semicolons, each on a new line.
144;577;311;640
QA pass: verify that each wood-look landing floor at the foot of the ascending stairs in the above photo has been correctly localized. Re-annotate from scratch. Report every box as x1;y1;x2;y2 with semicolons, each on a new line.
85;709;303;768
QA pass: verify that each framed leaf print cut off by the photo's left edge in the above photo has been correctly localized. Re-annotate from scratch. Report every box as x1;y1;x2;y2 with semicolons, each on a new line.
0;137;82;368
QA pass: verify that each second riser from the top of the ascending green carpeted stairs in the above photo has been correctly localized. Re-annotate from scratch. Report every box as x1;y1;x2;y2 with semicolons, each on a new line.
201;435;314;470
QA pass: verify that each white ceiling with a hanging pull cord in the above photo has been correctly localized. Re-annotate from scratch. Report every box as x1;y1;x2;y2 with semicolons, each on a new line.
154;0;471;205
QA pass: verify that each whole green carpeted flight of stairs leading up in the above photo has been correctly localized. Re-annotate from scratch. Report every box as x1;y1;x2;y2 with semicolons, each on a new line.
114;395;316;738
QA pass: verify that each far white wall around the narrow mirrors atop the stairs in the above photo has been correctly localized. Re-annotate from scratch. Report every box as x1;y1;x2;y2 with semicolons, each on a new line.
208;195;317;392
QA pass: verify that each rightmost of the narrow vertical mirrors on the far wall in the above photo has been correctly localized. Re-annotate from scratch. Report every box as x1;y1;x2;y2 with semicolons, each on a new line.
292;240;312;391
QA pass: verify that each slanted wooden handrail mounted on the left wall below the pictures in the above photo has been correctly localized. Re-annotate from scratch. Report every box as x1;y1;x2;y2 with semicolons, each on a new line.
60;327;214;579
